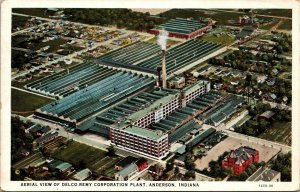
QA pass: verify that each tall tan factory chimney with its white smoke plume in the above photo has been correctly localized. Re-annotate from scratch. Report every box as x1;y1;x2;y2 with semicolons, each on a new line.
157;29;169;88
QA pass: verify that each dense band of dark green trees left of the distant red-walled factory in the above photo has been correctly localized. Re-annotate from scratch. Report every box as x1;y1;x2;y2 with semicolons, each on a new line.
64;9;162;31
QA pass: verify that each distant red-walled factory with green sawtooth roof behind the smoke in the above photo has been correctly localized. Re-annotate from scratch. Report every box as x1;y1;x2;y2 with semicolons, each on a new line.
148;18;212;39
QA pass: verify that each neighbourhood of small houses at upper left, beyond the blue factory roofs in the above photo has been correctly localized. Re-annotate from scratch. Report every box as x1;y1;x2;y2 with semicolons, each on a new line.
13;15;133;82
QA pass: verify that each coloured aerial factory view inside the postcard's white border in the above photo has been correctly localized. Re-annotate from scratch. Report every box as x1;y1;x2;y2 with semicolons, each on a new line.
10;8;292;182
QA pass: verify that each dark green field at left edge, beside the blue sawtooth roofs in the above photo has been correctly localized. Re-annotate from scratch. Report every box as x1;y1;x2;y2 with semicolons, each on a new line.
11;89;52;116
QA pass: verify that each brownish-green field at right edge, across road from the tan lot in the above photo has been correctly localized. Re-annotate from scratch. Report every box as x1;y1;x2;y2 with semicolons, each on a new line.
259;122;292;145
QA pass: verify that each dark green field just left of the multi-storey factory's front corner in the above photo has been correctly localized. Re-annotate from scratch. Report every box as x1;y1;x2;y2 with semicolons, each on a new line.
53;141;121;176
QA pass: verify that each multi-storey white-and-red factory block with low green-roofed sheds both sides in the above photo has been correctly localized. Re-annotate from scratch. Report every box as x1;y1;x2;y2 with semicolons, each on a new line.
77;80;214;159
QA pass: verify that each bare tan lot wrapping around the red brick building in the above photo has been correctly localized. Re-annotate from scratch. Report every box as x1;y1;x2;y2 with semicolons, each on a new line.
195;137;278;170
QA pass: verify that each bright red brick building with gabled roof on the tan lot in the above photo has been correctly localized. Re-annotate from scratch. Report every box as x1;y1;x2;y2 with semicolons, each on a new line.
222;146;259;175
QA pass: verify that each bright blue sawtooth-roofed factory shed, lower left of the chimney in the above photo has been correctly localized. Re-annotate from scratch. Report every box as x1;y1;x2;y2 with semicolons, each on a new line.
35;72;154;123
